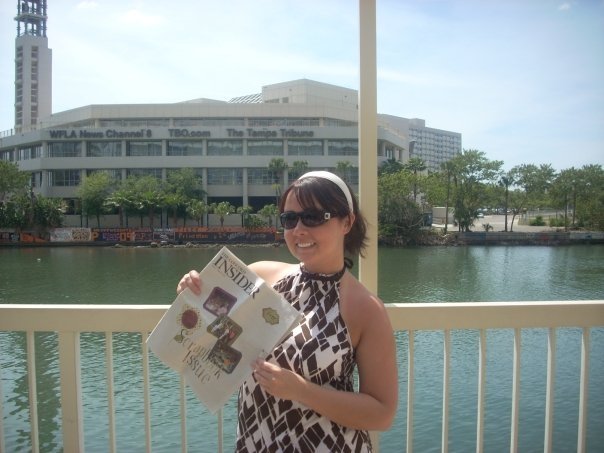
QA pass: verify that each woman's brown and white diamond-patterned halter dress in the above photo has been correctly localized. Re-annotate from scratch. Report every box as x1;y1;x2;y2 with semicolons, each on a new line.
236;266;371;453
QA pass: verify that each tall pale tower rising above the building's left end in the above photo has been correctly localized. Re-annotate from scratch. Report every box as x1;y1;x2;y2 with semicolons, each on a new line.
15;0;52;132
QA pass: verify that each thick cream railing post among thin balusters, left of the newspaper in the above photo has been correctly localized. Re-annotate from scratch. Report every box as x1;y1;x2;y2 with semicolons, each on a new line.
59;332;84;453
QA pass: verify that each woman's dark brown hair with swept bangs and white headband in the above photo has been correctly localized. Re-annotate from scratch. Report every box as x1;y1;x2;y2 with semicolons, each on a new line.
279;176;367;256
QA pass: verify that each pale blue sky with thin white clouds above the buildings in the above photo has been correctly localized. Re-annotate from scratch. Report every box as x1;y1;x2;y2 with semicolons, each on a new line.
0;0;604;171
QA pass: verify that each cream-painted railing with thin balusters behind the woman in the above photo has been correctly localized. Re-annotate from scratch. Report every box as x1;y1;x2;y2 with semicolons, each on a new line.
0;300;604;453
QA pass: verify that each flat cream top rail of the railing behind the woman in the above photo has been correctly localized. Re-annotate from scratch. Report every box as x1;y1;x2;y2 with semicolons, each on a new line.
0;300;604;332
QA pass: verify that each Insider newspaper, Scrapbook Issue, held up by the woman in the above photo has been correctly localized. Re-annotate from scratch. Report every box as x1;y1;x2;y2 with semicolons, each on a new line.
147;247;301;413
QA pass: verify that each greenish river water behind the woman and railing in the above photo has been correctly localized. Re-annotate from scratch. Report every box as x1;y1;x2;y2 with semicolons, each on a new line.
0;245;604;453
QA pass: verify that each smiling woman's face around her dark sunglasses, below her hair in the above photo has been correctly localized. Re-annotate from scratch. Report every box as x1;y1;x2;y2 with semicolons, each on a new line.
284;192;350;274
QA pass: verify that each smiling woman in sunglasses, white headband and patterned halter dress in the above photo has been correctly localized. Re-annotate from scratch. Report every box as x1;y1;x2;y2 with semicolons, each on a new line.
177;171;398;453
